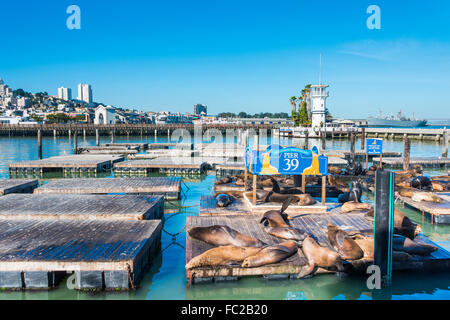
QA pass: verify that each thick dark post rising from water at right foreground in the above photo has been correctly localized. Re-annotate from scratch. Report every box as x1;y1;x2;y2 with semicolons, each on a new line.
373;170;395;287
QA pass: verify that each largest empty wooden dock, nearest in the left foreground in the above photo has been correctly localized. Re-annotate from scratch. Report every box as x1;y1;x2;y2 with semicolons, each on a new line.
0;219;162;290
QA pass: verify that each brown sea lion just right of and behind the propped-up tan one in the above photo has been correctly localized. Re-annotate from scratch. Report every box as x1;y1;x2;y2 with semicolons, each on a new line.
327;223;364;260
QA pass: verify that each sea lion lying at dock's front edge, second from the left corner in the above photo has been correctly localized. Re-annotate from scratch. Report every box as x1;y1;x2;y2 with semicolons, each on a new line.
242;241;298;268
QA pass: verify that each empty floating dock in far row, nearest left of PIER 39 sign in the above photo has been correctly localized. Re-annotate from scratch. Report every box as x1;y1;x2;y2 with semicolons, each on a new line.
114;157;208;174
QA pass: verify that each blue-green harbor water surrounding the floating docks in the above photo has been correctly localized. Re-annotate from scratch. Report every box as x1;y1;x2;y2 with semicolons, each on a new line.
0;136;450;300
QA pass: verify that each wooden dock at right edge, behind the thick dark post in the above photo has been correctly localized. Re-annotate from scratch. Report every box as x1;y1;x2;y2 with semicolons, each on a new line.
397;192;450;224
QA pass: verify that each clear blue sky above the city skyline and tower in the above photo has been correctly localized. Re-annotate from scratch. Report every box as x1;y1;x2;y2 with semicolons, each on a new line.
0;0;450;118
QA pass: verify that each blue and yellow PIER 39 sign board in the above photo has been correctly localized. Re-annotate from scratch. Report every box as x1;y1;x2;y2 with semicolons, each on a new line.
245;145;328;175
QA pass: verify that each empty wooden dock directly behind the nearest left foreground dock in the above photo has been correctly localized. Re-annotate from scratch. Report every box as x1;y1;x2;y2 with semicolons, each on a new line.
0;194;164;220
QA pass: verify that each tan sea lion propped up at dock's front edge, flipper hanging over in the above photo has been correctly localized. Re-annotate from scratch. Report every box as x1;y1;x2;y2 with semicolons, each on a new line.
297;236;344;278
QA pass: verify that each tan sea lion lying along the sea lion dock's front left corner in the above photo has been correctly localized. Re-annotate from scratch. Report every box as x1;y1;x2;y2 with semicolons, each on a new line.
186;246;262;269
